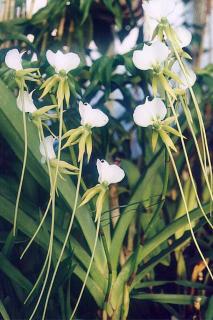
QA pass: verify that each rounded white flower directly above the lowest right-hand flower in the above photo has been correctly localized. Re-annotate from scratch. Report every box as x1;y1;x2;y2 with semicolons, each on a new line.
133;41;170;70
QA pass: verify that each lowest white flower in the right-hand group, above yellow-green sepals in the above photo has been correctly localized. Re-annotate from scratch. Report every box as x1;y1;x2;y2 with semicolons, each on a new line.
133;98;167;128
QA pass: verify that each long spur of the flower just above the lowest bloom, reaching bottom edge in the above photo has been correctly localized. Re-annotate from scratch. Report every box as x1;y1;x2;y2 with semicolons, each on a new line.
42;158;83;320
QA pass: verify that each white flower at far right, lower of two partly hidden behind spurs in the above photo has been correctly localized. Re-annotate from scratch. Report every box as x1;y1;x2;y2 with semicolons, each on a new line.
172;61;197;90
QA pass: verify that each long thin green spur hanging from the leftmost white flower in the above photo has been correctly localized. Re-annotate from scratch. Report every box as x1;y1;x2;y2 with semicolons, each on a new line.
13;81;28;236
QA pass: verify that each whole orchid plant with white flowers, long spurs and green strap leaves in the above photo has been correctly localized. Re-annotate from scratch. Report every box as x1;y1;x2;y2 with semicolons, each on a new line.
0;0;213;320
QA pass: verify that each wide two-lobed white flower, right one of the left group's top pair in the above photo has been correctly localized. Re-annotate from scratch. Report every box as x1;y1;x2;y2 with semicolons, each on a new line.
46;50;80;73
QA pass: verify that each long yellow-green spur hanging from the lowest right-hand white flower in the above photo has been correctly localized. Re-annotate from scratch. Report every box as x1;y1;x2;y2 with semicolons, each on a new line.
167;147;213;280
